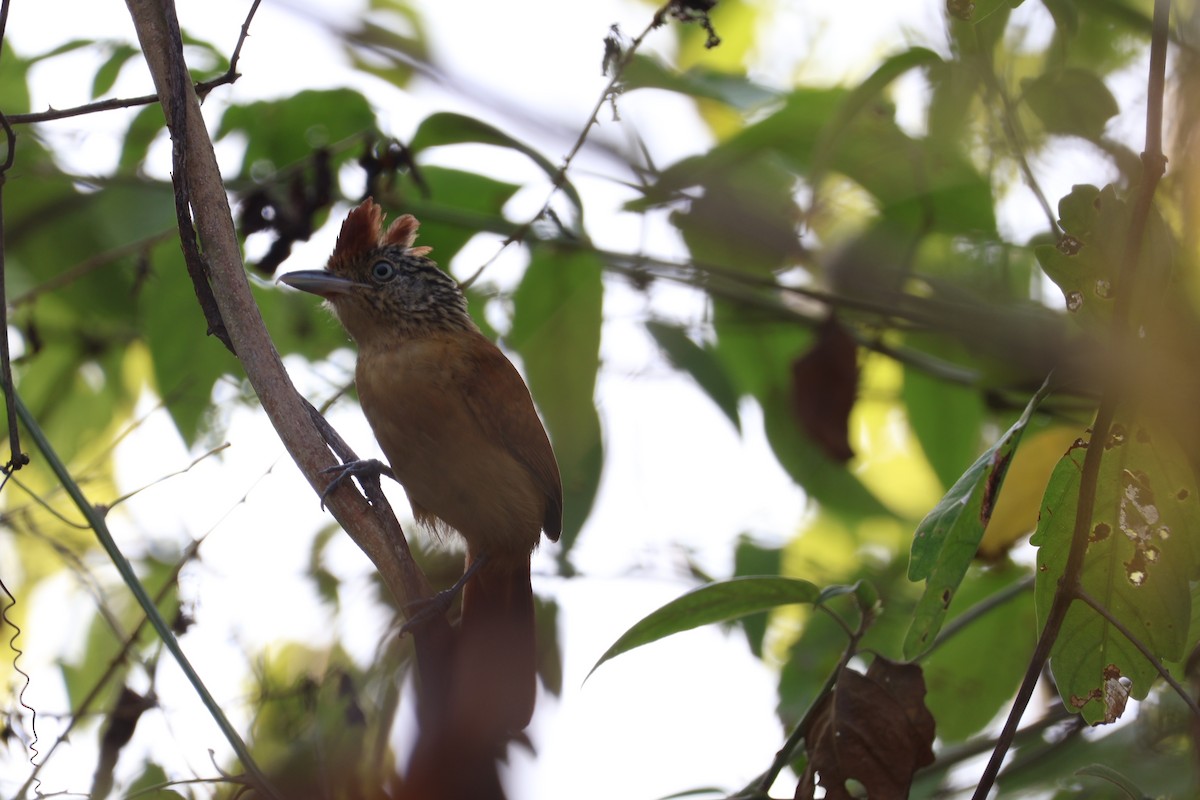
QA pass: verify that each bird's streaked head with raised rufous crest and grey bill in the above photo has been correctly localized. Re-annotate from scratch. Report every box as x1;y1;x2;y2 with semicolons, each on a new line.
280;198;476;345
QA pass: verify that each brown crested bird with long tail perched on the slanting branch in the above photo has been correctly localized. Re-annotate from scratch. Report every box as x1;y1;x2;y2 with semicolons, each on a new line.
280;197;563;741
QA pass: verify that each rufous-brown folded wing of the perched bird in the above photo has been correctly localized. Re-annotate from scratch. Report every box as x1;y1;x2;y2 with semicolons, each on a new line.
467;335;563;542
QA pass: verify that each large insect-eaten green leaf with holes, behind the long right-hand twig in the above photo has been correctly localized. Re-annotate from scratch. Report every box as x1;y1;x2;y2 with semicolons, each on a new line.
1030;422;1200;724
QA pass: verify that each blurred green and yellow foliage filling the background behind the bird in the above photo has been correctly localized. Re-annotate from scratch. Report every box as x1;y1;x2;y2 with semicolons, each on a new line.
0;0;1200;796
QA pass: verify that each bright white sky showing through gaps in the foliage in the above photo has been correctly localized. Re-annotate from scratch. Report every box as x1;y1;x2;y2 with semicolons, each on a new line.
0;0;1137;800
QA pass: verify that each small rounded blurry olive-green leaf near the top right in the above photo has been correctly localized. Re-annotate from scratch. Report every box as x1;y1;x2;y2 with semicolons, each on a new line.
1024;67;1121;142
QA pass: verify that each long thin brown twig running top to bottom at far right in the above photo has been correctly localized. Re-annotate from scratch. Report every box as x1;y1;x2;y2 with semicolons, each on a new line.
973;0;1171;800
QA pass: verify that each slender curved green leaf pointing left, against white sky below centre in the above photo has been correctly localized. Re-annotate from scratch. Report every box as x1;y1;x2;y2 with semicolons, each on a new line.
588;577;821;675
